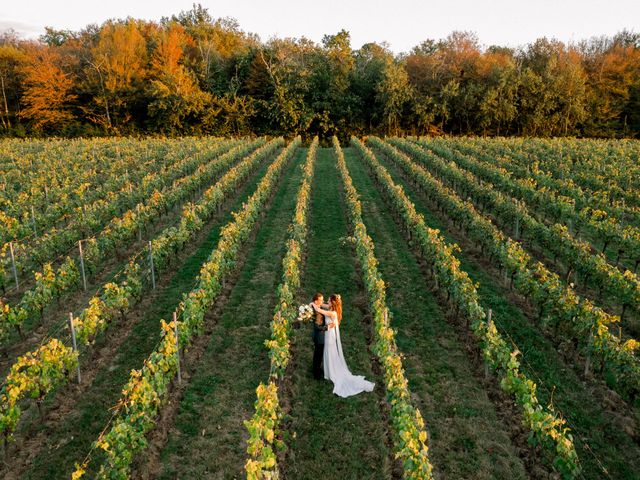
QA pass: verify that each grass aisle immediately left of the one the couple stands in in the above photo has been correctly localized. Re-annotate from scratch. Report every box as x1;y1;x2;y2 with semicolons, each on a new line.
159;149;306;479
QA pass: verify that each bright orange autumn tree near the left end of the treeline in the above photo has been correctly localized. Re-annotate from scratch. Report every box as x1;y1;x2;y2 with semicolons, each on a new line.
20;47;76;132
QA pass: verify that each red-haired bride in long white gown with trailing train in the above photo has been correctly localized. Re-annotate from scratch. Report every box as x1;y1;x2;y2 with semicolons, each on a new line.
314;295;375;397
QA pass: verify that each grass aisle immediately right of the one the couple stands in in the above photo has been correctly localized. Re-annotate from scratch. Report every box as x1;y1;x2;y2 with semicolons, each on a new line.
344;148;526;479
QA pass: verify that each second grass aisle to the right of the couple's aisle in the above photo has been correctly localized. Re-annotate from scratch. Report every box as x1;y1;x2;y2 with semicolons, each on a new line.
370;146;640;479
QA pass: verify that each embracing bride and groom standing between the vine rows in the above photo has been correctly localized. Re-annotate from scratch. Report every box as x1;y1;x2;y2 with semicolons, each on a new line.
311;293;375;397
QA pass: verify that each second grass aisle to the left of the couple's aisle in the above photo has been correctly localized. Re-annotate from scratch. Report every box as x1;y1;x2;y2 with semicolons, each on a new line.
16;151;278;480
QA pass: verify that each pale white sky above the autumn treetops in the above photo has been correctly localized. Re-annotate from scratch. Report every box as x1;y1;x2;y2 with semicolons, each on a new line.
0;0;640;53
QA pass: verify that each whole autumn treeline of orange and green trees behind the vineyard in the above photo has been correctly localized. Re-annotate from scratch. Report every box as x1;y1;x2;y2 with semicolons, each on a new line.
0;5;640;138
